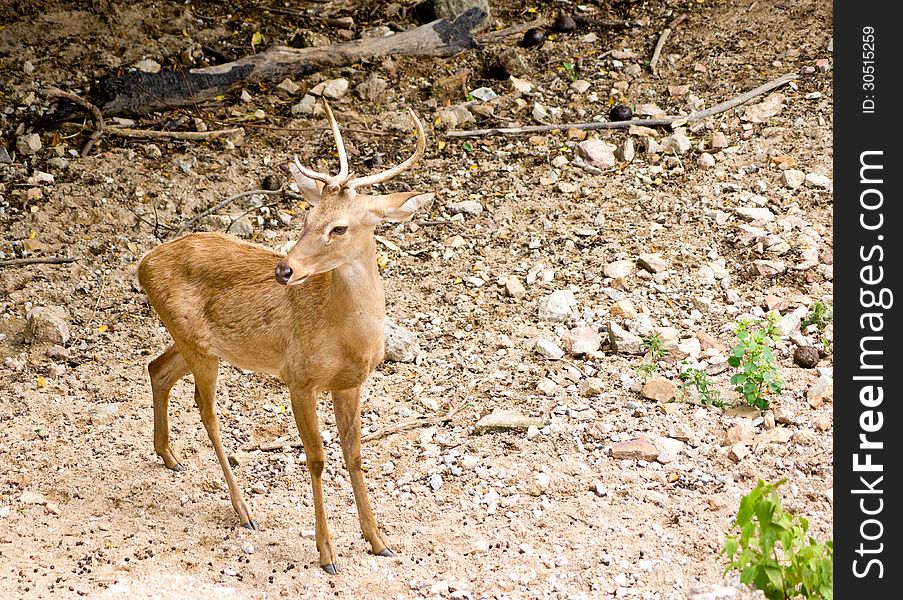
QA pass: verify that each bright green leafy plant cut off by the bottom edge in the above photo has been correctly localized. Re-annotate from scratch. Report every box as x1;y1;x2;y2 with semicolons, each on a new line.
722;479;834;600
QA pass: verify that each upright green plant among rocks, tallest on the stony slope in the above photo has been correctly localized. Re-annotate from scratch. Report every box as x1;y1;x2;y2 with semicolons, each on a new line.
727;313;784;409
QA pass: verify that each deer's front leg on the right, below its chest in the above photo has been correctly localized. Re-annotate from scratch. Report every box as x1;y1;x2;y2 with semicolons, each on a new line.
332;387;395;556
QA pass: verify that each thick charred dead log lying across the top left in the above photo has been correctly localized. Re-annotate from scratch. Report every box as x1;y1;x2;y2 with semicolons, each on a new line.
48;8;486;121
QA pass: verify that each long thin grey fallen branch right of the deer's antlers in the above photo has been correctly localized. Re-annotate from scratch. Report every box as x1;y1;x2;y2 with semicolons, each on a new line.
445;73;799;137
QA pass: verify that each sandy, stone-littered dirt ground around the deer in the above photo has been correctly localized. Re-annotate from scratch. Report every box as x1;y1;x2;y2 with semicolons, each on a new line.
0;0;833;599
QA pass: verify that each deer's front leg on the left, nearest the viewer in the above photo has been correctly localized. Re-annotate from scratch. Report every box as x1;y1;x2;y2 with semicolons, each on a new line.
291;387;336;575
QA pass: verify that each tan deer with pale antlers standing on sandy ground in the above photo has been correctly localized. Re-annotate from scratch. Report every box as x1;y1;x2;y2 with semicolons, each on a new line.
138;99;434;575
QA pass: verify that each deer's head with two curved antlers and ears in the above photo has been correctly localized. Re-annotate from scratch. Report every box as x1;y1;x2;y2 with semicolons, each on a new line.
276;100;433;285
